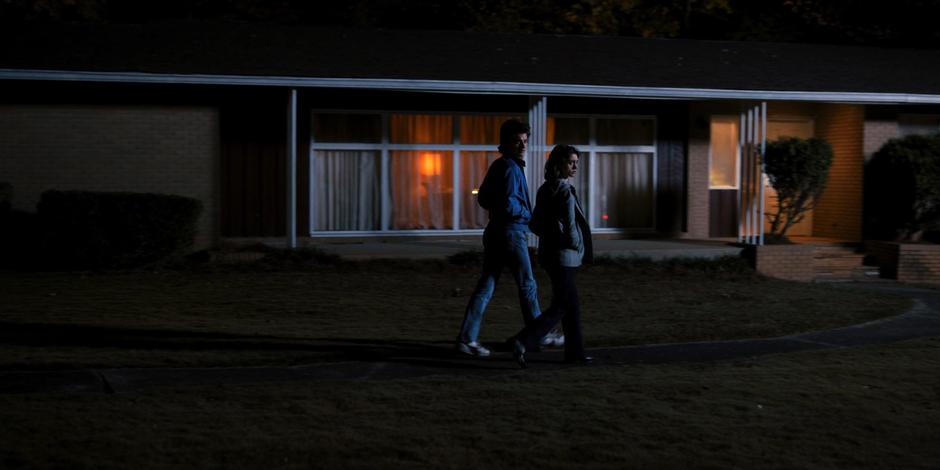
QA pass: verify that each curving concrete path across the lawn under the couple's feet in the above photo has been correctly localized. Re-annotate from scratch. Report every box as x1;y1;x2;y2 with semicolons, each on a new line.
0;285;940;393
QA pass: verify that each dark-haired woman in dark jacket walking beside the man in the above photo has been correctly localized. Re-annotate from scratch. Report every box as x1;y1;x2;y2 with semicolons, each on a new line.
509;145;594;368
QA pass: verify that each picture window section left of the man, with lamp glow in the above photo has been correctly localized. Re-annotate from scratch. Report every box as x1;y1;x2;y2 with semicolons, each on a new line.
310;112;521;234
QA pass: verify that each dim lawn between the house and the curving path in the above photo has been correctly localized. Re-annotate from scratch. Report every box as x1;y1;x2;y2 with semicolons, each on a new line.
0;258;910;370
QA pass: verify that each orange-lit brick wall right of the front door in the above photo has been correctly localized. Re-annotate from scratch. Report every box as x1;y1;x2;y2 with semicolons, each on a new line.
813;104;865;240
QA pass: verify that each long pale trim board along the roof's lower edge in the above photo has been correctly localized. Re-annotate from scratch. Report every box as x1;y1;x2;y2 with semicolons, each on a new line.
0;69;940;104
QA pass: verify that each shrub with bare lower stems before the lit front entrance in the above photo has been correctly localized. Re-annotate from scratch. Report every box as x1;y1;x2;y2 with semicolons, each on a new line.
764;137;832;239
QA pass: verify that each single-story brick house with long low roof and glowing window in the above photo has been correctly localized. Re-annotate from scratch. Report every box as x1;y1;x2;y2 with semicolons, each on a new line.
0;22;940;250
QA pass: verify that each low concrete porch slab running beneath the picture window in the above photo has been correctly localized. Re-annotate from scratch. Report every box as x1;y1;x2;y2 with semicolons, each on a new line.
314;237;742;260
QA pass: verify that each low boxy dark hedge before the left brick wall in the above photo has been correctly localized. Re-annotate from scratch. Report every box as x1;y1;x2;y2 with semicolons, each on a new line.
38;191;202;268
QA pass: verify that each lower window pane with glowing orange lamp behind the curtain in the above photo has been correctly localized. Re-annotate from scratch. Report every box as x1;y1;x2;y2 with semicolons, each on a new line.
389;151;454;230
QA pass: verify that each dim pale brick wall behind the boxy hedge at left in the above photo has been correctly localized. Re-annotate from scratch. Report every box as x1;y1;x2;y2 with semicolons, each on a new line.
0;105;219;248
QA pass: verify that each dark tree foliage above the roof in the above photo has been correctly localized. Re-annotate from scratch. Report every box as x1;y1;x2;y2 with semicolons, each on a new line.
0;0;940;47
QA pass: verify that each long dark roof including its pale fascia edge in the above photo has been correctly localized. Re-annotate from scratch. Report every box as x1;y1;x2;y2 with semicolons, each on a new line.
0;22;940;103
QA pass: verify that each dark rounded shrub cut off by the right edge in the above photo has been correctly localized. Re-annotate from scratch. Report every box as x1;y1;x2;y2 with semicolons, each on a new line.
865;135;940;241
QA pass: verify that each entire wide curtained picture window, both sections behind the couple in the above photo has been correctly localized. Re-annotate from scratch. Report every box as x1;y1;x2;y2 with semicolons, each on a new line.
309;111;656;235
